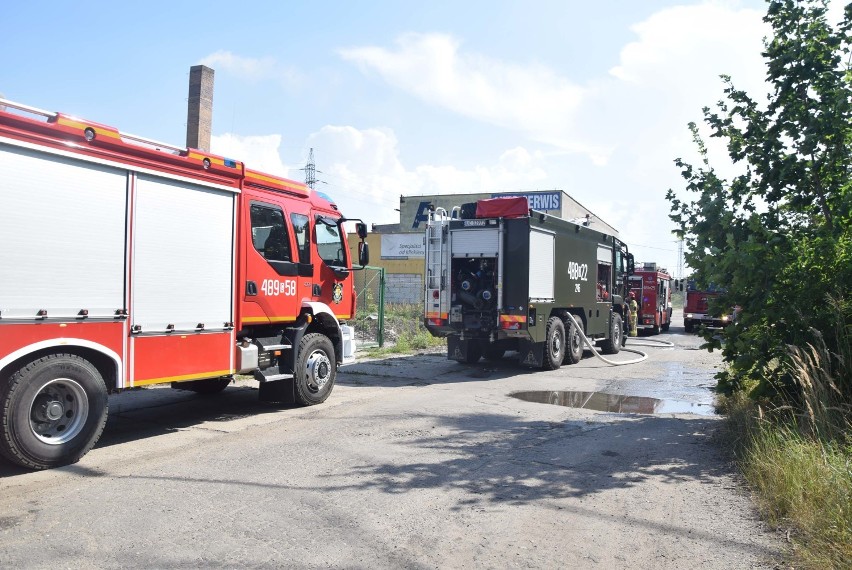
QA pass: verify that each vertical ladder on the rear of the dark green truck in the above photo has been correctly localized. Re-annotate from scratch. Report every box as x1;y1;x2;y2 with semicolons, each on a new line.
423;208;450;320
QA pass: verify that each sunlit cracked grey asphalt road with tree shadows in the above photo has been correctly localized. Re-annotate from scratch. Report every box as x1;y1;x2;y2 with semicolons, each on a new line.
0;312;782;569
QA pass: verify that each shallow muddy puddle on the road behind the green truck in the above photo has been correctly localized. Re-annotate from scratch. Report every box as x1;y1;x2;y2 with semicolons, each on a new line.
509;390;716;416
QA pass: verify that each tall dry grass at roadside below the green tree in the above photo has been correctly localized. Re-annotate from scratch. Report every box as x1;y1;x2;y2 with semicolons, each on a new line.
727;326;852;569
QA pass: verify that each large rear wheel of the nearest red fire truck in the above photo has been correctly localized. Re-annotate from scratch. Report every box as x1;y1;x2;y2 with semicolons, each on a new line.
0;354;108;469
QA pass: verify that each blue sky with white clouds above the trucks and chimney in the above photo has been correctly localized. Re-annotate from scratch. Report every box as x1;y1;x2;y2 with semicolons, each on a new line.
0;0;840;271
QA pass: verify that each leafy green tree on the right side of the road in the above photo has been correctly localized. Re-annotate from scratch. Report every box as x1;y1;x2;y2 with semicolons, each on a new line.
667;0;852;398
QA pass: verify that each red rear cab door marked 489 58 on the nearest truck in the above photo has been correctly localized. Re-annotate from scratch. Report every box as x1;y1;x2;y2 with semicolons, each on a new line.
242;193;310;324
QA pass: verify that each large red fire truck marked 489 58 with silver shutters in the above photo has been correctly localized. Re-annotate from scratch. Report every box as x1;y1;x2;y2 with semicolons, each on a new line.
0;100;367;469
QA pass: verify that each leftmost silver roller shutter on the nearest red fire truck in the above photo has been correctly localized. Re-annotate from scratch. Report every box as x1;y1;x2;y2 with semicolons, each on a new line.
0;143;127;319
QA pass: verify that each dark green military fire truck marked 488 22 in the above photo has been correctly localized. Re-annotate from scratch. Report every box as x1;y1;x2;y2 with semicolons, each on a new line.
424;197;633;370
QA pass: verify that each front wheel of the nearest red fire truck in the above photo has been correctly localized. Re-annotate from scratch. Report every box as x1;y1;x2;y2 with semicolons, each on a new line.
293;333;337;406
